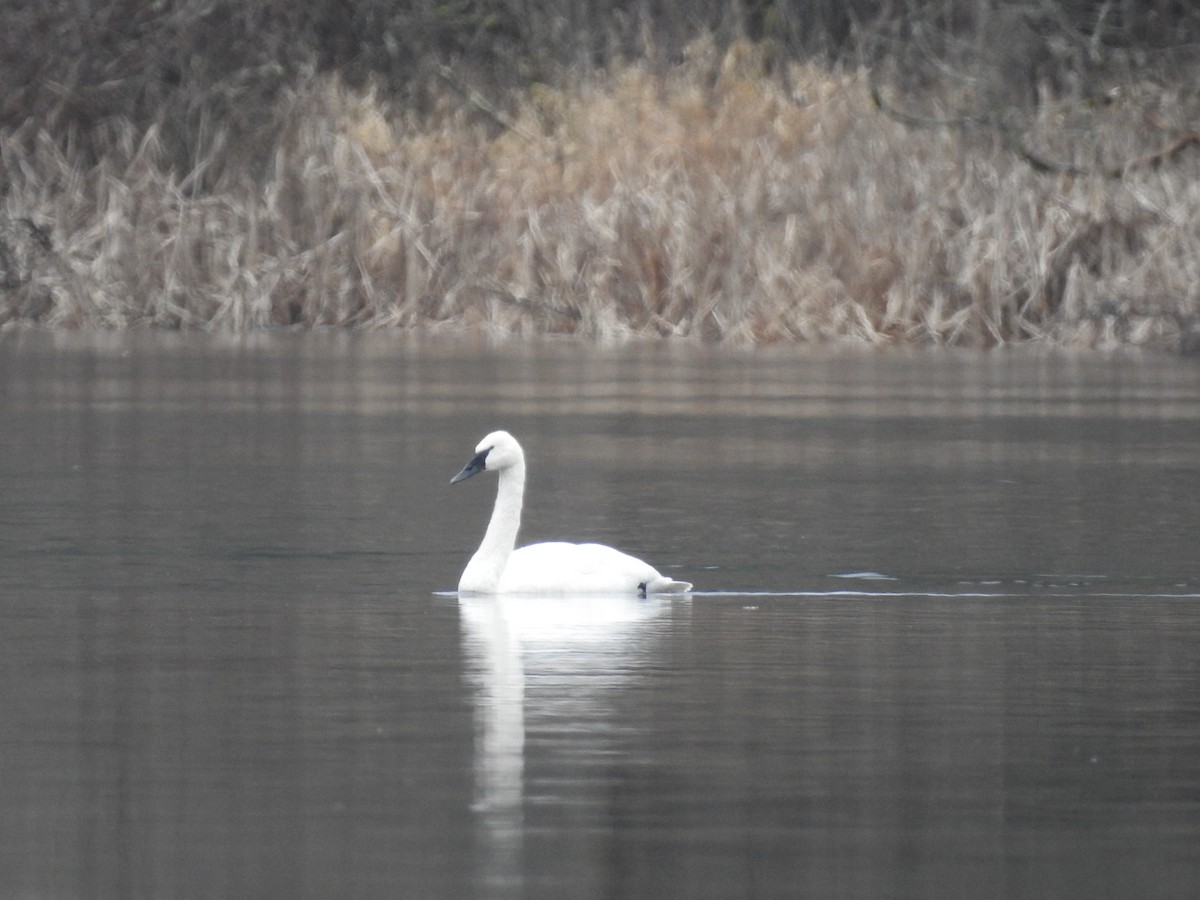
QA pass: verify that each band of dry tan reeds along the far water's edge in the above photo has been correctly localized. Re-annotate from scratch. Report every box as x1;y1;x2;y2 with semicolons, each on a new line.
7;44;1200;347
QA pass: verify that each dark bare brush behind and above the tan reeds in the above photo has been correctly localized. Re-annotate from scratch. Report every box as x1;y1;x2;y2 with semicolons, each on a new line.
0;0;1200;184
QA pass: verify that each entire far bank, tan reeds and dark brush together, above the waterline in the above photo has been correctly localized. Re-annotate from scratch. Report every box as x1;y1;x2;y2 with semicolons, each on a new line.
0;0;1200;350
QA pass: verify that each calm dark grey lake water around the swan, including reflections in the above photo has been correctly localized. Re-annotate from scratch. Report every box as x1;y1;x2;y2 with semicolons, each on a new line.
0;332;1200;900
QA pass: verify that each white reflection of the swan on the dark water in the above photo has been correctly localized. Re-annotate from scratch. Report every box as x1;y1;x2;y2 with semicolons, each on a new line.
458;594;672;890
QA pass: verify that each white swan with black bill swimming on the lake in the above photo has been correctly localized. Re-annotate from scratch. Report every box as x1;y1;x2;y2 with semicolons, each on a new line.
450;431;691;596
